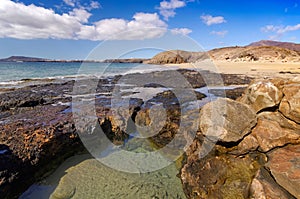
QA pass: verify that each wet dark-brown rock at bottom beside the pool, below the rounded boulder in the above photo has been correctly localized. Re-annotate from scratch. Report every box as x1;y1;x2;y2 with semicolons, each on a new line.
181;151;258;199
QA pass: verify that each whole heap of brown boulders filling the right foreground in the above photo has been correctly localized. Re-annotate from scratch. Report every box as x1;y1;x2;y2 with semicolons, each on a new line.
181;79;300;199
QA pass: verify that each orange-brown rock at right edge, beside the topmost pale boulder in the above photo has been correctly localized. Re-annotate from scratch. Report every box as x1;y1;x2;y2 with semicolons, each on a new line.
279;82;300;123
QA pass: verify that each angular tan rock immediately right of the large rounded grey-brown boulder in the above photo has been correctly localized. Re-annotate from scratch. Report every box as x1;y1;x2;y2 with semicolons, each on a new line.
252;112;300;152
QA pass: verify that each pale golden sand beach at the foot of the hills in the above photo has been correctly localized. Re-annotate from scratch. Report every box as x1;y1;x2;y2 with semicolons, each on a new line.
165;60;300;78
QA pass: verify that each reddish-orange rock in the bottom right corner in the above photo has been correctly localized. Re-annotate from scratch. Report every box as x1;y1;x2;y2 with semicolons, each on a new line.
267;145;300;198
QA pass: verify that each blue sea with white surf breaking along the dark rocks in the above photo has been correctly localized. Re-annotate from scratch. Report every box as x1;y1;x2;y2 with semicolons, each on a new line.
0;62;176;85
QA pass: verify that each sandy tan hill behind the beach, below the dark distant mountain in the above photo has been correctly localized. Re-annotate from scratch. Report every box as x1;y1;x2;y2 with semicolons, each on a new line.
209;46;300;62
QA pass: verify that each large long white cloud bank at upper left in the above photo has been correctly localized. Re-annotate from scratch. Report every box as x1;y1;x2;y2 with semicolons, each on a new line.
0;0;167;40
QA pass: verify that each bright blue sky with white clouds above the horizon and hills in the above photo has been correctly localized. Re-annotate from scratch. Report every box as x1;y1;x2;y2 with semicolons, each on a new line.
0;0;300;59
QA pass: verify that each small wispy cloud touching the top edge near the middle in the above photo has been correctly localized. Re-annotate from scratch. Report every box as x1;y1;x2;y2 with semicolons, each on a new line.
158;0;186;20
